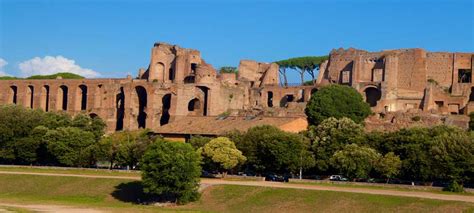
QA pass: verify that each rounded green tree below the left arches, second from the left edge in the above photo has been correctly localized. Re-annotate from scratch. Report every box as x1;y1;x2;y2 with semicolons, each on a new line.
43;127;96;167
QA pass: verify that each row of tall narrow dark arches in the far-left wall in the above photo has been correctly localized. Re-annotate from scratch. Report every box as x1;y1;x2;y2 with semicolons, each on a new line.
8;84;93;112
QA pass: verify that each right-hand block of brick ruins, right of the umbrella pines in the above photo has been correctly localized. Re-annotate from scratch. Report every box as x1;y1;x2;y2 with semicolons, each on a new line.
316;48;474;130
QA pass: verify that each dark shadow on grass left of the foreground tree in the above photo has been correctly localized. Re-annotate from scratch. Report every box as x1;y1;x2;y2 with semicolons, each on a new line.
112;181;149;204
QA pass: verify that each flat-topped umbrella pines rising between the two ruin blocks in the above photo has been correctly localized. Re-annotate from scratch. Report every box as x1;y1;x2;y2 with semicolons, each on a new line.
275;56;329;86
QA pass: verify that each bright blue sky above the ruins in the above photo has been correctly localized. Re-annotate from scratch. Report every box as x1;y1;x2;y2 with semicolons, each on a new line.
0;0;474;82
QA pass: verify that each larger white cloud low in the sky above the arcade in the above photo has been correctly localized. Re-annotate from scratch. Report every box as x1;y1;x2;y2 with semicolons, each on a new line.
19;55;100;78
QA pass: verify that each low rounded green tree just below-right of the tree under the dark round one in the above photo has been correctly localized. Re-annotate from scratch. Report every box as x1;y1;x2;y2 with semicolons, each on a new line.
331;144;380;179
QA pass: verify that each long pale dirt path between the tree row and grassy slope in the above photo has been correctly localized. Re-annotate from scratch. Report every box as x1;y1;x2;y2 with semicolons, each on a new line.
0;171;474;203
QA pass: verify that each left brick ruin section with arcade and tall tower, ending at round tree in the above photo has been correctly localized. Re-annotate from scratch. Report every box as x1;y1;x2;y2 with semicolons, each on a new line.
0;43;314;138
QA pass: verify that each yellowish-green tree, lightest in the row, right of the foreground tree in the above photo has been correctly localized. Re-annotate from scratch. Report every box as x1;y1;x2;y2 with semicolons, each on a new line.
200;137;247;177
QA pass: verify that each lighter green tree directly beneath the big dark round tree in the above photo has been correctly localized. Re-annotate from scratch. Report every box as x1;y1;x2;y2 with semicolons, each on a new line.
306;118;364;172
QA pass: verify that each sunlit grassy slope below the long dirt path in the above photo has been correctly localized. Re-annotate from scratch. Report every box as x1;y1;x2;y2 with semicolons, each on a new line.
0;174;474;212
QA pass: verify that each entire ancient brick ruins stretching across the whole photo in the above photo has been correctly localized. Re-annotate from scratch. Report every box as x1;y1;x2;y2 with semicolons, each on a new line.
0;43;474;137
